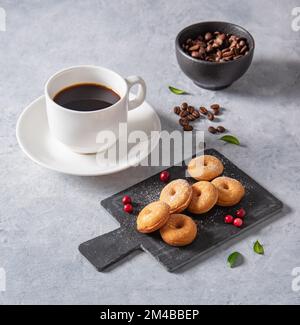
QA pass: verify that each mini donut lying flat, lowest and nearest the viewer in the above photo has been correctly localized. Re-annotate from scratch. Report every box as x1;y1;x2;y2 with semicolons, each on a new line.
160;214;197;246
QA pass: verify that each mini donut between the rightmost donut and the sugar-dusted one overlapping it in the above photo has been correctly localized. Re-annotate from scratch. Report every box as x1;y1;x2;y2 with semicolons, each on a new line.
188;181;218;214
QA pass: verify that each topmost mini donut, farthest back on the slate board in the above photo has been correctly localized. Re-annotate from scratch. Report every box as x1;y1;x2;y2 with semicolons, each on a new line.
187;155;224;181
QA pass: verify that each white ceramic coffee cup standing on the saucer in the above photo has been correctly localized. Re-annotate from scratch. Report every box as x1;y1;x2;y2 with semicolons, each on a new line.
45;65;146;154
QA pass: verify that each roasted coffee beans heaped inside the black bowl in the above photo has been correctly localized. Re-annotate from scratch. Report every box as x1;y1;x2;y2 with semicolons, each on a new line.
182;32;249;63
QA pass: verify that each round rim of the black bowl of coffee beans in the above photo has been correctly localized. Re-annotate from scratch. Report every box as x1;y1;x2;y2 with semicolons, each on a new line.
175;20;255;65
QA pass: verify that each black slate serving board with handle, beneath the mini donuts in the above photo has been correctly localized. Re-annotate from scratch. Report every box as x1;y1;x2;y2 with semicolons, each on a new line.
79;149;282;272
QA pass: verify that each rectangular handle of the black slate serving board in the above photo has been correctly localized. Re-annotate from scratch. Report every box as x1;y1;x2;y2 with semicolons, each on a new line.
79;227;140;272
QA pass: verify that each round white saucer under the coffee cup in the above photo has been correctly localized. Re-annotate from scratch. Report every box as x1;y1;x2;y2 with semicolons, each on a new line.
16;96;161;176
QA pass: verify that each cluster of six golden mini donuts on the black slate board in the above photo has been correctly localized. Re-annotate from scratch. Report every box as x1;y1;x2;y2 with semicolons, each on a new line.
137;155;245;246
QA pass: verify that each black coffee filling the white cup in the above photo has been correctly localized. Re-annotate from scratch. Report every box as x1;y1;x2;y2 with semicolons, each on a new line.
53;83;120;112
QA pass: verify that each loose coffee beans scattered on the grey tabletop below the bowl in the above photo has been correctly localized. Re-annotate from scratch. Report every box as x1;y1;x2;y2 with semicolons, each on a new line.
174;103;226;133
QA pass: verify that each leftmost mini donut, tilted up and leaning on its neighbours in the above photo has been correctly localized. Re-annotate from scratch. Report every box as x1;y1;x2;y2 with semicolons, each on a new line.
136;201;170;234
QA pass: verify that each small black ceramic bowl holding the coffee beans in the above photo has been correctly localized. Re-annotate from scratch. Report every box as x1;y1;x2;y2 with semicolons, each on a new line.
176;21;255;90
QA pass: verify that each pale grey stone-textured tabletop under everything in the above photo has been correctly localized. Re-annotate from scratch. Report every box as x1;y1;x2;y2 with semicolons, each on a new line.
0;0;300;304
